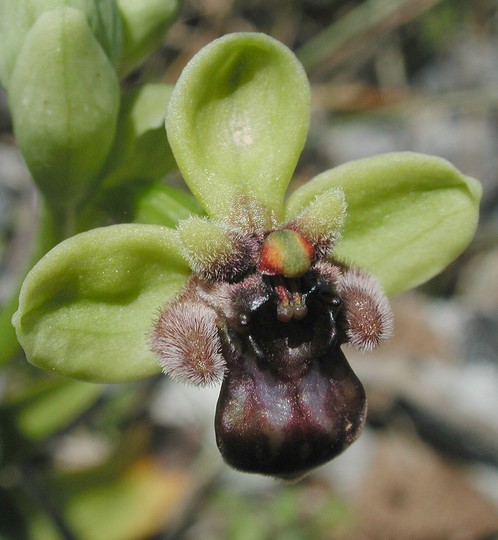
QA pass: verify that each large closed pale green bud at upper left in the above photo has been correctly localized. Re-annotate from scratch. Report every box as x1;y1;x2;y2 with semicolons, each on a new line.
8;8;120;207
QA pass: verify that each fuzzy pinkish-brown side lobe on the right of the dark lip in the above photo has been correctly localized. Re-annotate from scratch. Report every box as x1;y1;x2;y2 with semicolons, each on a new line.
338;268;393;351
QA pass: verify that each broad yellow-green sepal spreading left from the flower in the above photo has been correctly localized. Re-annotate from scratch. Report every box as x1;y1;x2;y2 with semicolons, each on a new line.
13;224;189;382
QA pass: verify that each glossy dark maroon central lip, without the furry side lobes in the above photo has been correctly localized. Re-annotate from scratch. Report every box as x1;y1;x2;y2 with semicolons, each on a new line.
215;280;366;479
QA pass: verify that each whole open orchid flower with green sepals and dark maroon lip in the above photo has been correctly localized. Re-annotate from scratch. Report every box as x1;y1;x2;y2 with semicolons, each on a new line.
14;33;480;479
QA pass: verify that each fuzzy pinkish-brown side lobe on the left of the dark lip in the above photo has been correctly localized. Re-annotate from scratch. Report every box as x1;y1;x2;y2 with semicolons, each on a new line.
151;298;225;386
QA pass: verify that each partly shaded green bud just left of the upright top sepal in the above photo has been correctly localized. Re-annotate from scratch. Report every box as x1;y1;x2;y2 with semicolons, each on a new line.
102;83;176;188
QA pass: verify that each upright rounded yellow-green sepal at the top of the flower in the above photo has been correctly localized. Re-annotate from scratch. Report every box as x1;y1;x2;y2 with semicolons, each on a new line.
166;33;310;218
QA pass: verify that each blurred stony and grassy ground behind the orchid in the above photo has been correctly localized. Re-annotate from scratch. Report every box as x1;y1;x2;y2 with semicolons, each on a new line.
0;0;498;540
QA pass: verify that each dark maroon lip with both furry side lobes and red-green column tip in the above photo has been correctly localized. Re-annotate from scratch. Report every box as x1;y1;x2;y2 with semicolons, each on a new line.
151;215;392;479
